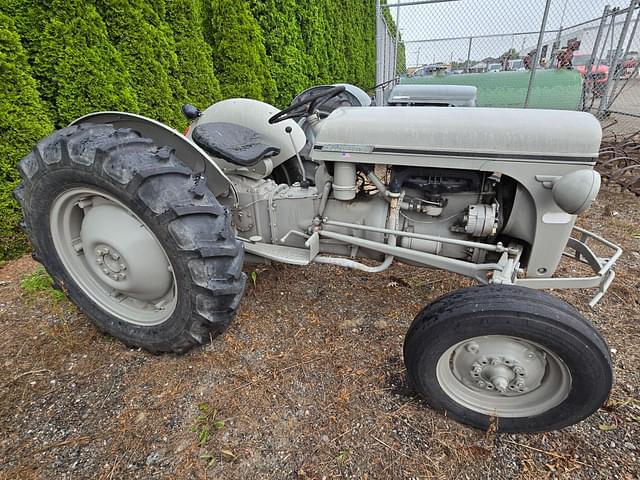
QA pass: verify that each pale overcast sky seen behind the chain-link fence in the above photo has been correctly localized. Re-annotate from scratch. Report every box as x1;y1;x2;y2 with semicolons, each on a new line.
387;0;629;66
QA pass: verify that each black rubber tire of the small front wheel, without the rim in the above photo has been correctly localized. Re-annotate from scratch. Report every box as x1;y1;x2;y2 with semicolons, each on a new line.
404;285;613;433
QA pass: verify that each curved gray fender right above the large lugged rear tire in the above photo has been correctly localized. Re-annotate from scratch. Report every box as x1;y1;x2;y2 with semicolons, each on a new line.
69;112;238;206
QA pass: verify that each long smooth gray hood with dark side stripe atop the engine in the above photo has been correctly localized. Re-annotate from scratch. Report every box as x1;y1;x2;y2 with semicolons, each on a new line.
313;107;602;164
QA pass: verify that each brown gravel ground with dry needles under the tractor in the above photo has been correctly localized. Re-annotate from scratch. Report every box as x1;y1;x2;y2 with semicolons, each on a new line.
0;185;640;479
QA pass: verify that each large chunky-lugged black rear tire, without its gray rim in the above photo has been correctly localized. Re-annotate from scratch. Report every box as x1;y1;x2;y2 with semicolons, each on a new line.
14;124;246;353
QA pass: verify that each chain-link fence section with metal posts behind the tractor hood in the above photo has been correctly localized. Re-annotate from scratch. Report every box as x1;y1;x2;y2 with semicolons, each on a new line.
376;0;640;131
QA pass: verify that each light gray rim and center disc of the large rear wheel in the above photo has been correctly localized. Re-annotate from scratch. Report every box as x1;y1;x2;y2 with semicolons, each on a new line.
50;187;177;327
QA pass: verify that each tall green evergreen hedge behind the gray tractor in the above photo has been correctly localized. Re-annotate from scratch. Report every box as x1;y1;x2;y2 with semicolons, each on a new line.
0;0;390;260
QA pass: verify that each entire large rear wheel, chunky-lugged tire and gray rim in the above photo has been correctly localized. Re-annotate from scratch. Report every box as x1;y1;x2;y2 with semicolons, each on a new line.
15;125;245;353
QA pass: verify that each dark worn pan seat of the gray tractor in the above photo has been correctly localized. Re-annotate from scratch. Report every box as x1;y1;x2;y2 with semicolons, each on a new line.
192;122;280;167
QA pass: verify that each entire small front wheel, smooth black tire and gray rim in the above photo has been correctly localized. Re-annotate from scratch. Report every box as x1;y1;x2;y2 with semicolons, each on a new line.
404;285;613;432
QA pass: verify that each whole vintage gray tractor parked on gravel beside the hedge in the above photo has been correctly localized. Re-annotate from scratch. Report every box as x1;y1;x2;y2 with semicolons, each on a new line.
15;85;621;432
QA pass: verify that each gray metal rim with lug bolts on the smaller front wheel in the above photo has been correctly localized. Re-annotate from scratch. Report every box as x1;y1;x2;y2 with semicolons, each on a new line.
436;335;571;417
